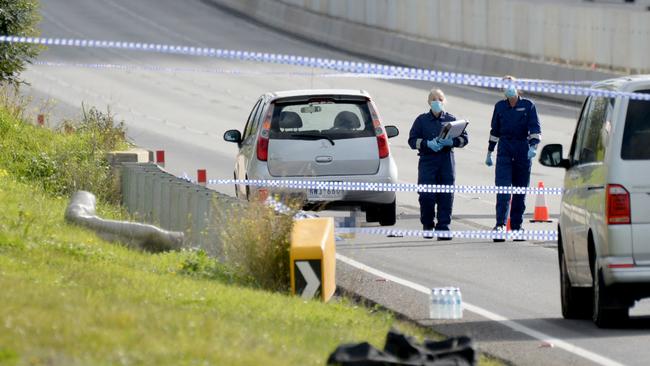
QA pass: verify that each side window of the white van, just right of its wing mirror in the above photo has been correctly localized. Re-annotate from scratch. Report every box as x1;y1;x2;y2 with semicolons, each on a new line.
580;98;614;164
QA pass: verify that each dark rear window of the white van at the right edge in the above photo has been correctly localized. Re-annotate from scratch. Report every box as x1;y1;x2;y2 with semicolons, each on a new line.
621;90;650;160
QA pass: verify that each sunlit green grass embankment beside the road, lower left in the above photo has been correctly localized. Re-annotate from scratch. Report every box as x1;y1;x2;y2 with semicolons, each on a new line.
0;96;502;365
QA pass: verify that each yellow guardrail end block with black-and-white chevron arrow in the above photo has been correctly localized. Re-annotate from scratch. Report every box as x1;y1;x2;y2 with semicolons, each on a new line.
289;217;336;302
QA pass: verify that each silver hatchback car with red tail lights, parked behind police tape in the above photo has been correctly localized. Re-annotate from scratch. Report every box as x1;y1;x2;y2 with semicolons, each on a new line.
224;90;399;225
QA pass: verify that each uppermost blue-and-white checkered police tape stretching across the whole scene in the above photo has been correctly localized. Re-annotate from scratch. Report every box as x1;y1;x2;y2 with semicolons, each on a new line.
5;36;650;100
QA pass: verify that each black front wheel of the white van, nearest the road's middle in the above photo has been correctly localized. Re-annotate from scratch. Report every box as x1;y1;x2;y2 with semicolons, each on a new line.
558;247;592;319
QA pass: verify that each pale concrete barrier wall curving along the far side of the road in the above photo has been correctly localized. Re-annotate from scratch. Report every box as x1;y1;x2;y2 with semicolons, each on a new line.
206;0;620;86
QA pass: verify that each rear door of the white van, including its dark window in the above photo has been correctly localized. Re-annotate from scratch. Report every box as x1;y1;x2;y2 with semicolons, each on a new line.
621;90;650;266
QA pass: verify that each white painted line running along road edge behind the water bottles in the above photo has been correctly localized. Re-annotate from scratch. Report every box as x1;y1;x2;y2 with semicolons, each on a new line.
336;253;623;366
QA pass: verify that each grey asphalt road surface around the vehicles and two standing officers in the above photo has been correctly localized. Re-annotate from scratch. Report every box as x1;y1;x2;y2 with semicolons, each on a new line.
24;0;650;365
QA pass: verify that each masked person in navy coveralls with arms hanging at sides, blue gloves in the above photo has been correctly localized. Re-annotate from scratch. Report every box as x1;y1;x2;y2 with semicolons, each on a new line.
485;76;542;242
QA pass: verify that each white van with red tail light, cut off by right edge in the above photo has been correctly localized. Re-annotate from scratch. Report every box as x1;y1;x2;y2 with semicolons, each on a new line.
540;75;650;327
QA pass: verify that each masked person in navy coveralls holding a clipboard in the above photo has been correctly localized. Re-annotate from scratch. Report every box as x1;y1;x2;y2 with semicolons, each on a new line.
408;89;469;240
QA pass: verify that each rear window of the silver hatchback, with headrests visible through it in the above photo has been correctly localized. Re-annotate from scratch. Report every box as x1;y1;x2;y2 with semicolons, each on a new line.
270;100;375;140
